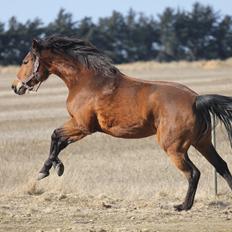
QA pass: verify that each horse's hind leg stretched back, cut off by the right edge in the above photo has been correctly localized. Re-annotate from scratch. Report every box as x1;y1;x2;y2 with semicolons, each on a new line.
194;142;232;190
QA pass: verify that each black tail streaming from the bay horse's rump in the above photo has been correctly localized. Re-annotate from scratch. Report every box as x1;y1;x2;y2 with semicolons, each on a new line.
196;94;232;147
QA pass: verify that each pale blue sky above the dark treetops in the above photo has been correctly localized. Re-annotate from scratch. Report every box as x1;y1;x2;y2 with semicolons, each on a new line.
0;0;232;24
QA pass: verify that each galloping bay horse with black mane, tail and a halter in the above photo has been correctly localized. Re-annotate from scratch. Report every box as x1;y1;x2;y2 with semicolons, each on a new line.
12;36;232;211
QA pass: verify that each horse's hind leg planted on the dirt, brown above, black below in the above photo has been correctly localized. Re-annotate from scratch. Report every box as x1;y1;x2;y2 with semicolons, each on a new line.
167;146;200;211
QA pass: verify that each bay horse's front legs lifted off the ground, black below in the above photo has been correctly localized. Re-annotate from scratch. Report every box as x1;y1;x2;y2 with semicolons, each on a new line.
38;119;89;180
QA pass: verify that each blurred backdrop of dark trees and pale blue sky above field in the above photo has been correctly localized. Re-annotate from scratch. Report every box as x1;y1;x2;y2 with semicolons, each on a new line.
0;0;232;65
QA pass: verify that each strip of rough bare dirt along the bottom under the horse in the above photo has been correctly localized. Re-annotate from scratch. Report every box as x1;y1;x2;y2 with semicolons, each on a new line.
0;193;232;232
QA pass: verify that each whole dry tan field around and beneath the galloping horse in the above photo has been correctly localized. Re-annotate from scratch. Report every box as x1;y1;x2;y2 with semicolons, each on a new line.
0;60;232;232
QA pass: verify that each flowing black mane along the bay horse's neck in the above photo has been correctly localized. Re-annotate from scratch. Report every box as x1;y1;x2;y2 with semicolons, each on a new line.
41;36;119;76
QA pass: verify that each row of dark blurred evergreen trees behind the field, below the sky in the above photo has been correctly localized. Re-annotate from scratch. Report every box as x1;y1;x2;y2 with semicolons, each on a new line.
0;2;232;65
